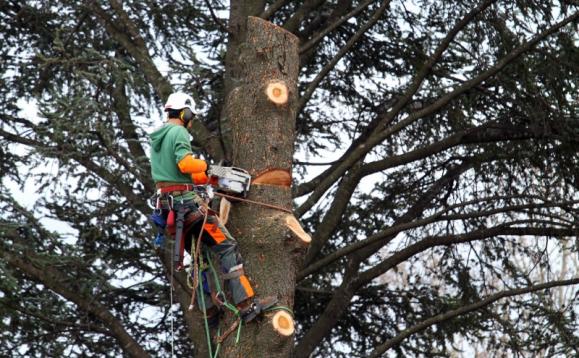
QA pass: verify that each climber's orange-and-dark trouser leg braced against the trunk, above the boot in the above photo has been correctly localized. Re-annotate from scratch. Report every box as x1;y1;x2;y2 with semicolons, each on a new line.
203;216;254;304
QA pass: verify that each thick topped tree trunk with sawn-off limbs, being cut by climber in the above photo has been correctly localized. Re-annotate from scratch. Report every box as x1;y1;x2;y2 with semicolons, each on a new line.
222;17;303;357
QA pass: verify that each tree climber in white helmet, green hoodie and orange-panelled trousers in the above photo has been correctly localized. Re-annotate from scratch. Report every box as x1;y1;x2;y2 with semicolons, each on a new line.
150;93;277;324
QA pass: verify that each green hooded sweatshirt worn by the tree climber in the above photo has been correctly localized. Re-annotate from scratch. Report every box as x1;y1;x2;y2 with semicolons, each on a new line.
149;123;192;184
